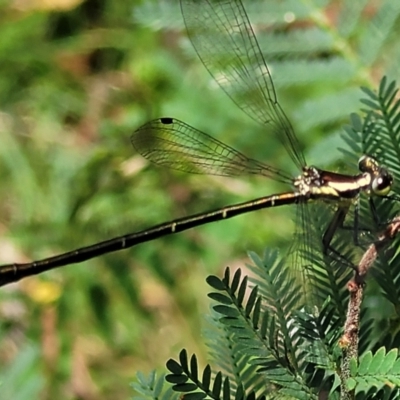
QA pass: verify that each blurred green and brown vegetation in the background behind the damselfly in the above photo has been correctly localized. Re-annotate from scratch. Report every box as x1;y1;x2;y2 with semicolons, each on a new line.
0;0;400;400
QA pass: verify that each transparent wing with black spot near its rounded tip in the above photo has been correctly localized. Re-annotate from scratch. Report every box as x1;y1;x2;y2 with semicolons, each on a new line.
131;118;292;183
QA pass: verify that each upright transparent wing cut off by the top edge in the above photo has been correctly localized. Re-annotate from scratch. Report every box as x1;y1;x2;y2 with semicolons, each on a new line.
181;0;305;169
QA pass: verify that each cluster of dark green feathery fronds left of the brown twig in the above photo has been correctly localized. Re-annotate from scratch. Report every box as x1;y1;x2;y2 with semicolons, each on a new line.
162;264;337;399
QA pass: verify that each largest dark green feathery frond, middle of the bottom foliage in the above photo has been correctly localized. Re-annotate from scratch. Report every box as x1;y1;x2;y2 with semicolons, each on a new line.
207;269;316;391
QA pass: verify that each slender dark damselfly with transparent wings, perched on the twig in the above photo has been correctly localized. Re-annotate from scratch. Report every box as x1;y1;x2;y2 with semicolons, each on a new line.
0;0;393;285
